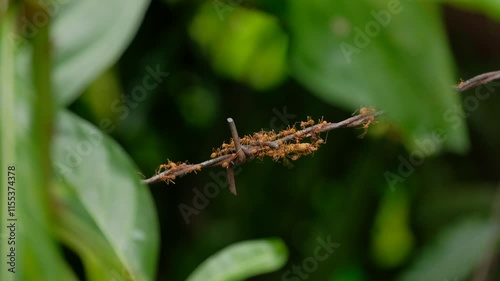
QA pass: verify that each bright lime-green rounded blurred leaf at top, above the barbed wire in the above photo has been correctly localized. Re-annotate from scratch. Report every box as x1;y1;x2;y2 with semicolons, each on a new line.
189;4;288;90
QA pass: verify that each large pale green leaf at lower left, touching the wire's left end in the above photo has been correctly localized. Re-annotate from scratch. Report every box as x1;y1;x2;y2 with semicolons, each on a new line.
53;109;158;280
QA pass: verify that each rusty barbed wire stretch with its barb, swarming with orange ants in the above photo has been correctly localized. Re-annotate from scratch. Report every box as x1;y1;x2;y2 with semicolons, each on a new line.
142;108;383;188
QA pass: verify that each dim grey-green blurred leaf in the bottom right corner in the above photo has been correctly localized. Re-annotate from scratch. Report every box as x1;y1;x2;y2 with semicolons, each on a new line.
398;219;498;281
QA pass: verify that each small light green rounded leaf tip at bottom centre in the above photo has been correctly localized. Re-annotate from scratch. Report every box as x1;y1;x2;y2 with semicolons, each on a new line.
187;239;288;281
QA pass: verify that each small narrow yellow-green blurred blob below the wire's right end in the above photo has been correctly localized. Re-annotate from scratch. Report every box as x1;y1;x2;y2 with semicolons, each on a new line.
372;189;414;268
